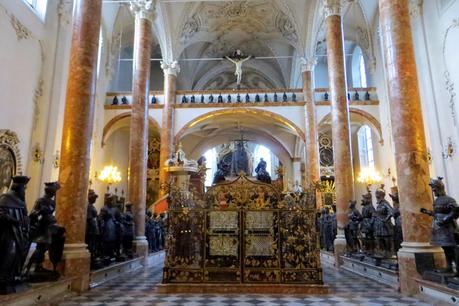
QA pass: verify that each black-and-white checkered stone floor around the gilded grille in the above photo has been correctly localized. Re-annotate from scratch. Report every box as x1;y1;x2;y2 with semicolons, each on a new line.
53;267;438;306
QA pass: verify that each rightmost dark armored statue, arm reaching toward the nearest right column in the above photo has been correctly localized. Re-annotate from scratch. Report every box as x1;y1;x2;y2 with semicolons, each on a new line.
421;177;459;275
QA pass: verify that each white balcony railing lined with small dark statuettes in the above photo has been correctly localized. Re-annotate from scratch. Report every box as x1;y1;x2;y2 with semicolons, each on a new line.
105;87;378;107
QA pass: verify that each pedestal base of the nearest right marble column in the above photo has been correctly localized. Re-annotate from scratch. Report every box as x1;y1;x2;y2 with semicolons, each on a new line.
397;242;445;295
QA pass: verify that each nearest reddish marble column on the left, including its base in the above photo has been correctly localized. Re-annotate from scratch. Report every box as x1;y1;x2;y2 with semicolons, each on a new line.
56;0;102;291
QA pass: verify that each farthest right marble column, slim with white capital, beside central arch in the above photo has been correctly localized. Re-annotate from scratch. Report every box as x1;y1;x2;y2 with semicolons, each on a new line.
301;57;322;208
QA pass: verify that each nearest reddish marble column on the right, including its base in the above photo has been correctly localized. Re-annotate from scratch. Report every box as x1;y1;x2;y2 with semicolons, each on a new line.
379;0;443;294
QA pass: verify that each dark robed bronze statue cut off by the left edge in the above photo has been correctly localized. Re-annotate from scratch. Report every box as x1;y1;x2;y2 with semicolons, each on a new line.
0;176;30;294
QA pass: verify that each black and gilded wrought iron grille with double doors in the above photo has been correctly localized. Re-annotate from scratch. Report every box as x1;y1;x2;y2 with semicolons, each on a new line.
163;175;322;284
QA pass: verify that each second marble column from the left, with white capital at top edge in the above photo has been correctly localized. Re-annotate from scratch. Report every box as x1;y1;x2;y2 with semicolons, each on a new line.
127;0;154;258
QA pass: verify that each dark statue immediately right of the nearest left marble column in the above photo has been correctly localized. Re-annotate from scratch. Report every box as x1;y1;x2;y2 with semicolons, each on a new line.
85;189;99;268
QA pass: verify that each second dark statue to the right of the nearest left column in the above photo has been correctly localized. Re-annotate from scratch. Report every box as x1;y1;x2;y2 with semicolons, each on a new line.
99;195;116;265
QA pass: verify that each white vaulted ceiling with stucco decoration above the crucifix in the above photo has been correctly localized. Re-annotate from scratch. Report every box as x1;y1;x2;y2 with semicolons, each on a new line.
103;0;378;90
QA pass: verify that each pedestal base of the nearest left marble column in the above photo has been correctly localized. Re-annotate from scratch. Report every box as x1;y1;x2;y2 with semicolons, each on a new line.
59;243;91;292
